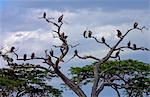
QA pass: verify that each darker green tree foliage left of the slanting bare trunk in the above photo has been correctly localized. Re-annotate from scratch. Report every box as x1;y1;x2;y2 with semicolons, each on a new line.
0;64;62;97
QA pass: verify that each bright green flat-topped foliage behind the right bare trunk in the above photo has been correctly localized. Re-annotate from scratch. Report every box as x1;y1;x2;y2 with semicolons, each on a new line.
70;59;150;96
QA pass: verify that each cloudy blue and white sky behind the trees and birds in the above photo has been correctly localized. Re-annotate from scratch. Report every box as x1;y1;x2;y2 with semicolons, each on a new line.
0;0;150;97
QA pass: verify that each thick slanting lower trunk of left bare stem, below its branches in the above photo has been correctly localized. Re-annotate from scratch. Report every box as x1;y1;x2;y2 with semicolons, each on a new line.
54;68;87;97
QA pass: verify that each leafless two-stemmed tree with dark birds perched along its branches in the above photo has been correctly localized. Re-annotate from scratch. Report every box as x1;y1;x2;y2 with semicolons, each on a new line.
0;12;150;97
